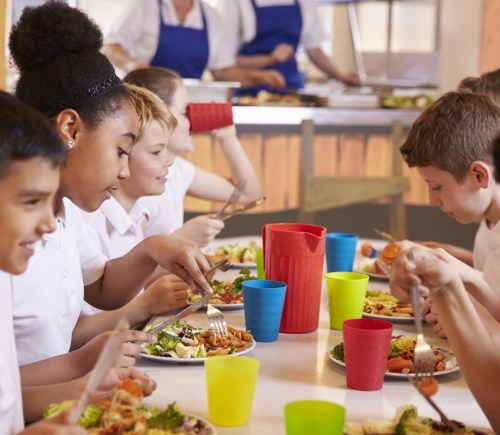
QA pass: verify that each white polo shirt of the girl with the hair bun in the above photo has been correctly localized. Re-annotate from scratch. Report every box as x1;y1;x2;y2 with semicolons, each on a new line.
12;198;107;365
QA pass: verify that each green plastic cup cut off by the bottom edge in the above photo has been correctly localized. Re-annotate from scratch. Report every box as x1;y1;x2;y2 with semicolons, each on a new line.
285;400;345;435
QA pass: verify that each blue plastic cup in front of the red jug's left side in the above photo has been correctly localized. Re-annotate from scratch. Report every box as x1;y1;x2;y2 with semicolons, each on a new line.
243;279;287;342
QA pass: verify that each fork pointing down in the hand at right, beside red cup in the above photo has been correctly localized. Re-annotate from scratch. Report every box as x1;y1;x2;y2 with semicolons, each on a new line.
407;251;435;385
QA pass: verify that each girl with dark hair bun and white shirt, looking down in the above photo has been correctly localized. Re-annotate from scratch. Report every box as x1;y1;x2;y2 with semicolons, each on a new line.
9;1;211;421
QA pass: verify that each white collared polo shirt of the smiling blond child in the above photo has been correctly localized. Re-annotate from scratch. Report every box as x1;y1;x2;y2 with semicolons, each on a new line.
82;197;148;316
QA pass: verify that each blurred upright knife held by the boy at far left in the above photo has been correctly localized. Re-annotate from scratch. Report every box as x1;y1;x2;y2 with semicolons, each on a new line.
68;318;129;424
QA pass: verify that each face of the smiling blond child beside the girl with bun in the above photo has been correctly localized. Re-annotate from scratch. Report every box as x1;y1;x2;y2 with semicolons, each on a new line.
120;121;173;199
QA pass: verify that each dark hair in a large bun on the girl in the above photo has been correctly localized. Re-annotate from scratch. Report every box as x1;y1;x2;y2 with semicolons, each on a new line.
9;0;128;126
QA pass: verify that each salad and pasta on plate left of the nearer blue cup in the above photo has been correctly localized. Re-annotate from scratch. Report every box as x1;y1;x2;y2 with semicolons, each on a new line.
143;321;253;358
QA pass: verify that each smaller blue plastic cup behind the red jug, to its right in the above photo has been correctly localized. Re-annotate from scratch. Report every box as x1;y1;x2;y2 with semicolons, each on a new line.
325;233;358;272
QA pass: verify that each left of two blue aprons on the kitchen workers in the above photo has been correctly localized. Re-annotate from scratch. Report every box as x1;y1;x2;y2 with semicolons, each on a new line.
151;0;209;79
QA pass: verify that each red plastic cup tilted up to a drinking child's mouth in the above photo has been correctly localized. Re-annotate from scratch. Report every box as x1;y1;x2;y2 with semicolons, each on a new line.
186;103;234;133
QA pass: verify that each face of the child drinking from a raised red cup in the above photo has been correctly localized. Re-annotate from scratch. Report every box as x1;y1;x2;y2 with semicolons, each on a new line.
168;83;194;156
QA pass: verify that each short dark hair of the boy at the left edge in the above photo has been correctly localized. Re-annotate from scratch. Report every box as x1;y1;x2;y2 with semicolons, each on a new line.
0;91;66;178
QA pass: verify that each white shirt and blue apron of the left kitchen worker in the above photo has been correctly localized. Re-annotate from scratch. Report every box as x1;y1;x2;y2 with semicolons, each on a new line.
105;0;235;79
